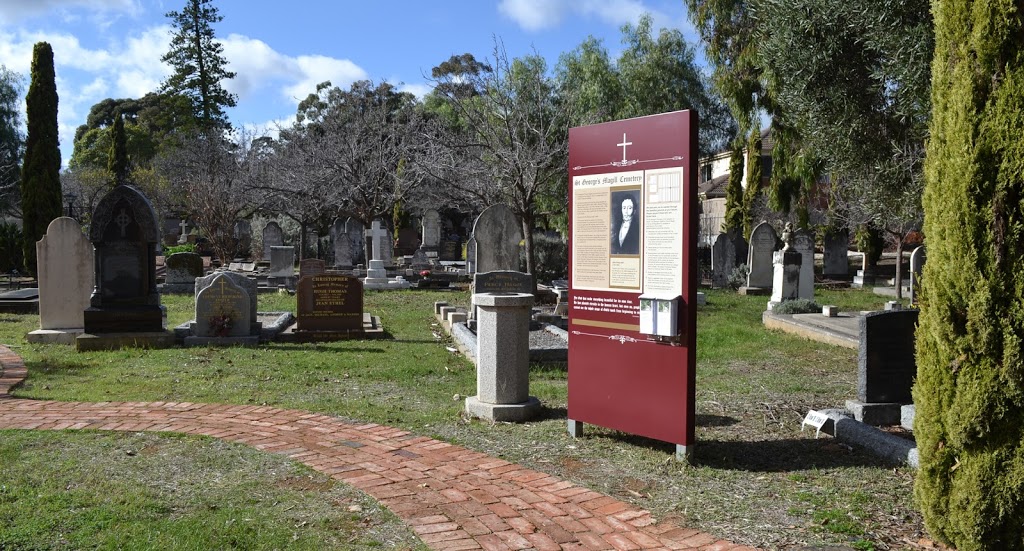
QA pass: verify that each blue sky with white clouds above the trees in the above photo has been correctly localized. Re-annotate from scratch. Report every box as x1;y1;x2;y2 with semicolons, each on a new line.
0;0;695;165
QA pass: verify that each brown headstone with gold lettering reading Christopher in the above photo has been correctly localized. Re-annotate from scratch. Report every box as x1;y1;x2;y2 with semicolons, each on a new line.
295;273;362;333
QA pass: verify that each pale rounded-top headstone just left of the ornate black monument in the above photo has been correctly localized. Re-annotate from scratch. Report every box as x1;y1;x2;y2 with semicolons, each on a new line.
28;216;95;337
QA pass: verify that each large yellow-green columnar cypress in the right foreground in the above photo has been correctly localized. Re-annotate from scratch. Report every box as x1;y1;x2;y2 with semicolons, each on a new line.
913;0;1024;551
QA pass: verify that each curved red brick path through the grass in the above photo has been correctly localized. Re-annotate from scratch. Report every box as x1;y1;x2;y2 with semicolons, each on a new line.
0;345;751;551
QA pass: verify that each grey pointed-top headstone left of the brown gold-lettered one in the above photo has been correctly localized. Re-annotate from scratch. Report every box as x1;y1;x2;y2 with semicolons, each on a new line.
193;272;253;338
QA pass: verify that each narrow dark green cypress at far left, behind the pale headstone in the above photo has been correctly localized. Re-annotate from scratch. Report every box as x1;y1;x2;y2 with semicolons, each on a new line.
22;42;60;274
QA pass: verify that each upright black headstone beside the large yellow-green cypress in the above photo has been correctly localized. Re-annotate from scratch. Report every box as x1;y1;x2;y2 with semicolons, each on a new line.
857;310;919;404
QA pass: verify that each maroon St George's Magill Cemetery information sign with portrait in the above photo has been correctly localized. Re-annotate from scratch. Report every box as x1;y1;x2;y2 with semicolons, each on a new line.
568;111;697;456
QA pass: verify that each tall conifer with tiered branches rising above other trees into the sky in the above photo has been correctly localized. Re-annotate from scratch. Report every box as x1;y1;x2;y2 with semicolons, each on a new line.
161;0;238;130
